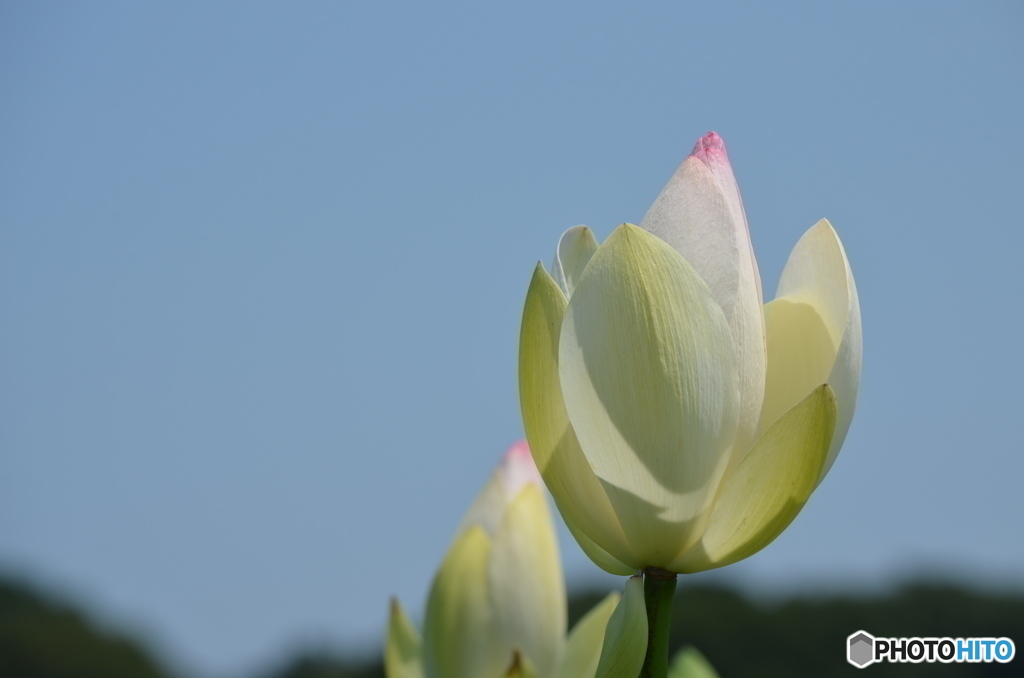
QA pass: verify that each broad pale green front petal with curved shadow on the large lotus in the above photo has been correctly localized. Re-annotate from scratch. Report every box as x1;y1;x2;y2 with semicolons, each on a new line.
558;224;739;566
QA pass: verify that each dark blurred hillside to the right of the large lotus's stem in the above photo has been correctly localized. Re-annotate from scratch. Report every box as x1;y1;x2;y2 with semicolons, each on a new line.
571;578;1024;678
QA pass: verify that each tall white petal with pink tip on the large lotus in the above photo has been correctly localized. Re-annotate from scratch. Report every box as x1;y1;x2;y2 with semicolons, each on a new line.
640;132;766;464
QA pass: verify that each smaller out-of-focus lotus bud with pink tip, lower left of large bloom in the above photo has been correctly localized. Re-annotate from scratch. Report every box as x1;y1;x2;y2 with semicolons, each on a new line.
385;442;626;678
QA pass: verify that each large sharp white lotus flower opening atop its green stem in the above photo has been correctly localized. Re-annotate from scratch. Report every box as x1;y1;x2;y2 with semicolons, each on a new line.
519;132;861;574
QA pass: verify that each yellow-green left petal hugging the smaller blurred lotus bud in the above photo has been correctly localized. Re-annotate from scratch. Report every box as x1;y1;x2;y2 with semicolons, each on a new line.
423;525;501;678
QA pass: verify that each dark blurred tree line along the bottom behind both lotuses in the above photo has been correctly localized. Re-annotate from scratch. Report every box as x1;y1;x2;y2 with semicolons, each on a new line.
0;579;1024;678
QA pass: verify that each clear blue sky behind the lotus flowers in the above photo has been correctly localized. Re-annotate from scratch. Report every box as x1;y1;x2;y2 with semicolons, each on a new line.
0;2;1024;676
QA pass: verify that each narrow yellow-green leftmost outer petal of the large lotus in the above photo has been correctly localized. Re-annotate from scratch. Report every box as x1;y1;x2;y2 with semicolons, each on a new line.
519;264;641;571
